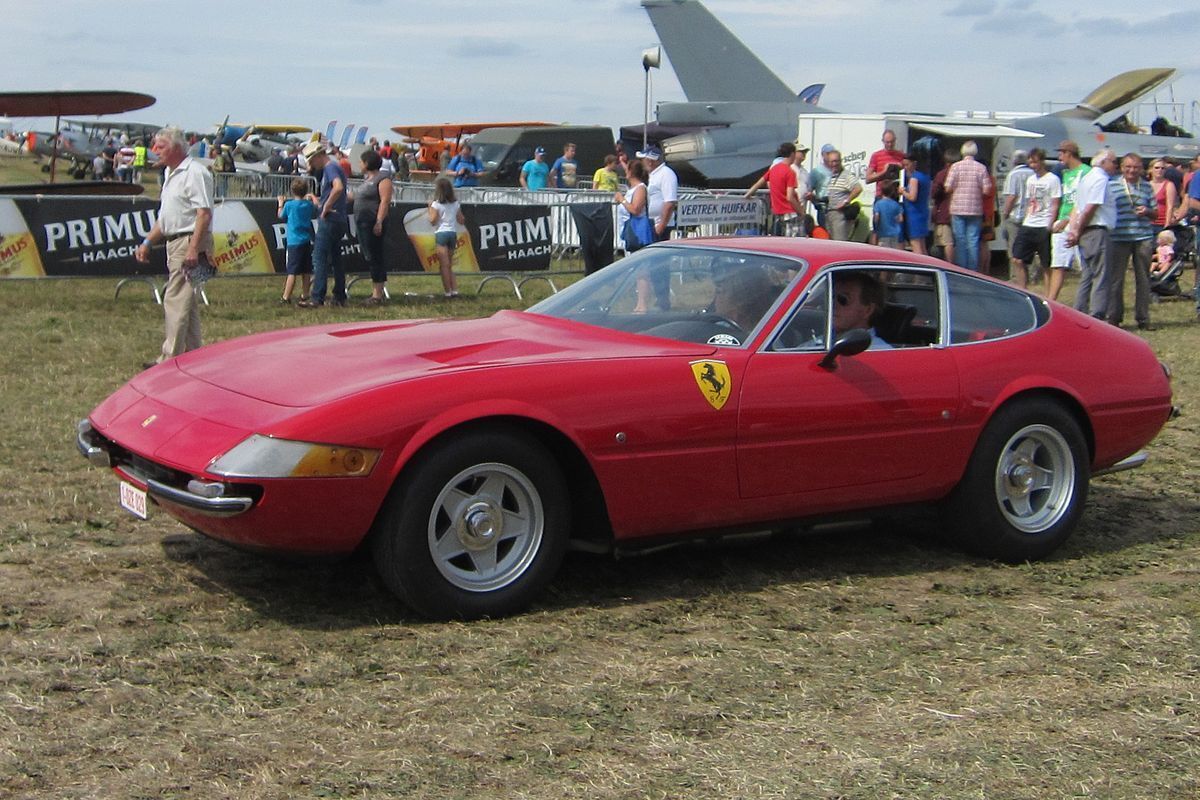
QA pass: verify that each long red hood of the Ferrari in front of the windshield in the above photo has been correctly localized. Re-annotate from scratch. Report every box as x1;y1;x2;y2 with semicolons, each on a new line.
160;311;714;408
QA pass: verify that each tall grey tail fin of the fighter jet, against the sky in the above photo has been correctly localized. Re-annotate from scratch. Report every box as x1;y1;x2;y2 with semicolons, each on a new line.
642;0;796;102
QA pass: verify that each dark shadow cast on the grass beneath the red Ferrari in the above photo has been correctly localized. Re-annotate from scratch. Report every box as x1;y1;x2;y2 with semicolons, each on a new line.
162;485;1200;630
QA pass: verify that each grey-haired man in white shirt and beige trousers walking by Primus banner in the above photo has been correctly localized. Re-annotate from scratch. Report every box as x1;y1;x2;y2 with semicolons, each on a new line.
133;127;212;367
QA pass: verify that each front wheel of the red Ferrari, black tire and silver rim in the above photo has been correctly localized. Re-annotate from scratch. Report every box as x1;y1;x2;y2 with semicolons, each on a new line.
371;429;570;619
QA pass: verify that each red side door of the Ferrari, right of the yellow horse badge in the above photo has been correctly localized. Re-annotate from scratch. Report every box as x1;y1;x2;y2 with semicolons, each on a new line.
737;268;960;513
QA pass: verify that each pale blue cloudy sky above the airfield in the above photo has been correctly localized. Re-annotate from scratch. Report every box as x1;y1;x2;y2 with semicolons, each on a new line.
0;0;1200;139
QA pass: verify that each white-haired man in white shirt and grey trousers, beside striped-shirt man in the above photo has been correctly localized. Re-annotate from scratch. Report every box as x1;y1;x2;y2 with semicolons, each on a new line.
1067;148;1117;319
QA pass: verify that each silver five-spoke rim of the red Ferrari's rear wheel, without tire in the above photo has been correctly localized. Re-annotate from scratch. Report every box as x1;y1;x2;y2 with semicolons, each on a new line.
996;425;1076;534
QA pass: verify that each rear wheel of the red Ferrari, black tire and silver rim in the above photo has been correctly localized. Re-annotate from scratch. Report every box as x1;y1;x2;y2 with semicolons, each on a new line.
942;398;1091;564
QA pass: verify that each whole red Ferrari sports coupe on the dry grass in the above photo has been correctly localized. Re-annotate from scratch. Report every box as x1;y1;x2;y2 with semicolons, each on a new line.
77;237;1172;618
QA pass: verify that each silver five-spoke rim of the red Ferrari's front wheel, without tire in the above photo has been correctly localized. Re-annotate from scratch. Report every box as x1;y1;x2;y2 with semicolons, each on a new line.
427;463;545;591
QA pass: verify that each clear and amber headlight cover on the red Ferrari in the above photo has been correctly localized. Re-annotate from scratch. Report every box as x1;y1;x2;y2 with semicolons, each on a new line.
209;433;379;477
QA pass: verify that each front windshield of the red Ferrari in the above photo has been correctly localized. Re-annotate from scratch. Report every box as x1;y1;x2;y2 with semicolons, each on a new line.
529;246;804;347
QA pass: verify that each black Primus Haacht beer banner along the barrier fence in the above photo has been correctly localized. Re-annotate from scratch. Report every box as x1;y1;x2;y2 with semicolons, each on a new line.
0;197;553;278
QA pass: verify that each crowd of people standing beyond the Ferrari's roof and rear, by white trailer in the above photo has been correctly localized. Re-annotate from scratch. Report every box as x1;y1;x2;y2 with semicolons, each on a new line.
746;131;1200;330
